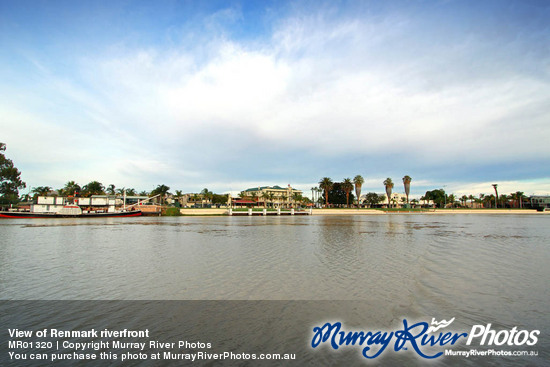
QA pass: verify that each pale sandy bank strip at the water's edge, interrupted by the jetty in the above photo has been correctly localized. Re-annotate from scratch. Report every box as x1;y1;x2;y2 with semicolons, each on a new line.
180;208;550;217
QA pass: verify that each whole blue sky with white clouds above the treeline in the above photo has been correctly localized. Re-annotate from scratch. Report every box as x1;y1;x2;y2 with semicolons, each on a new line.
0;0;550;197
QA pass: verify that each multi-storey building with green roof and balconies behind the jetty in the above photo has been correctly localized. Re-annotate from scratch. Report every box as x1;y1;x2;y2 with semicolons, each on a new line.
239;185;303;208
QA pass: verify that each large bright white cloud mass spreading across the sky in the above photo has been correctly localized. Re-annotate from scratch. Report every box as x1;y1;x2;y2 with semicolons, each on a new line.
0;5;550;193
